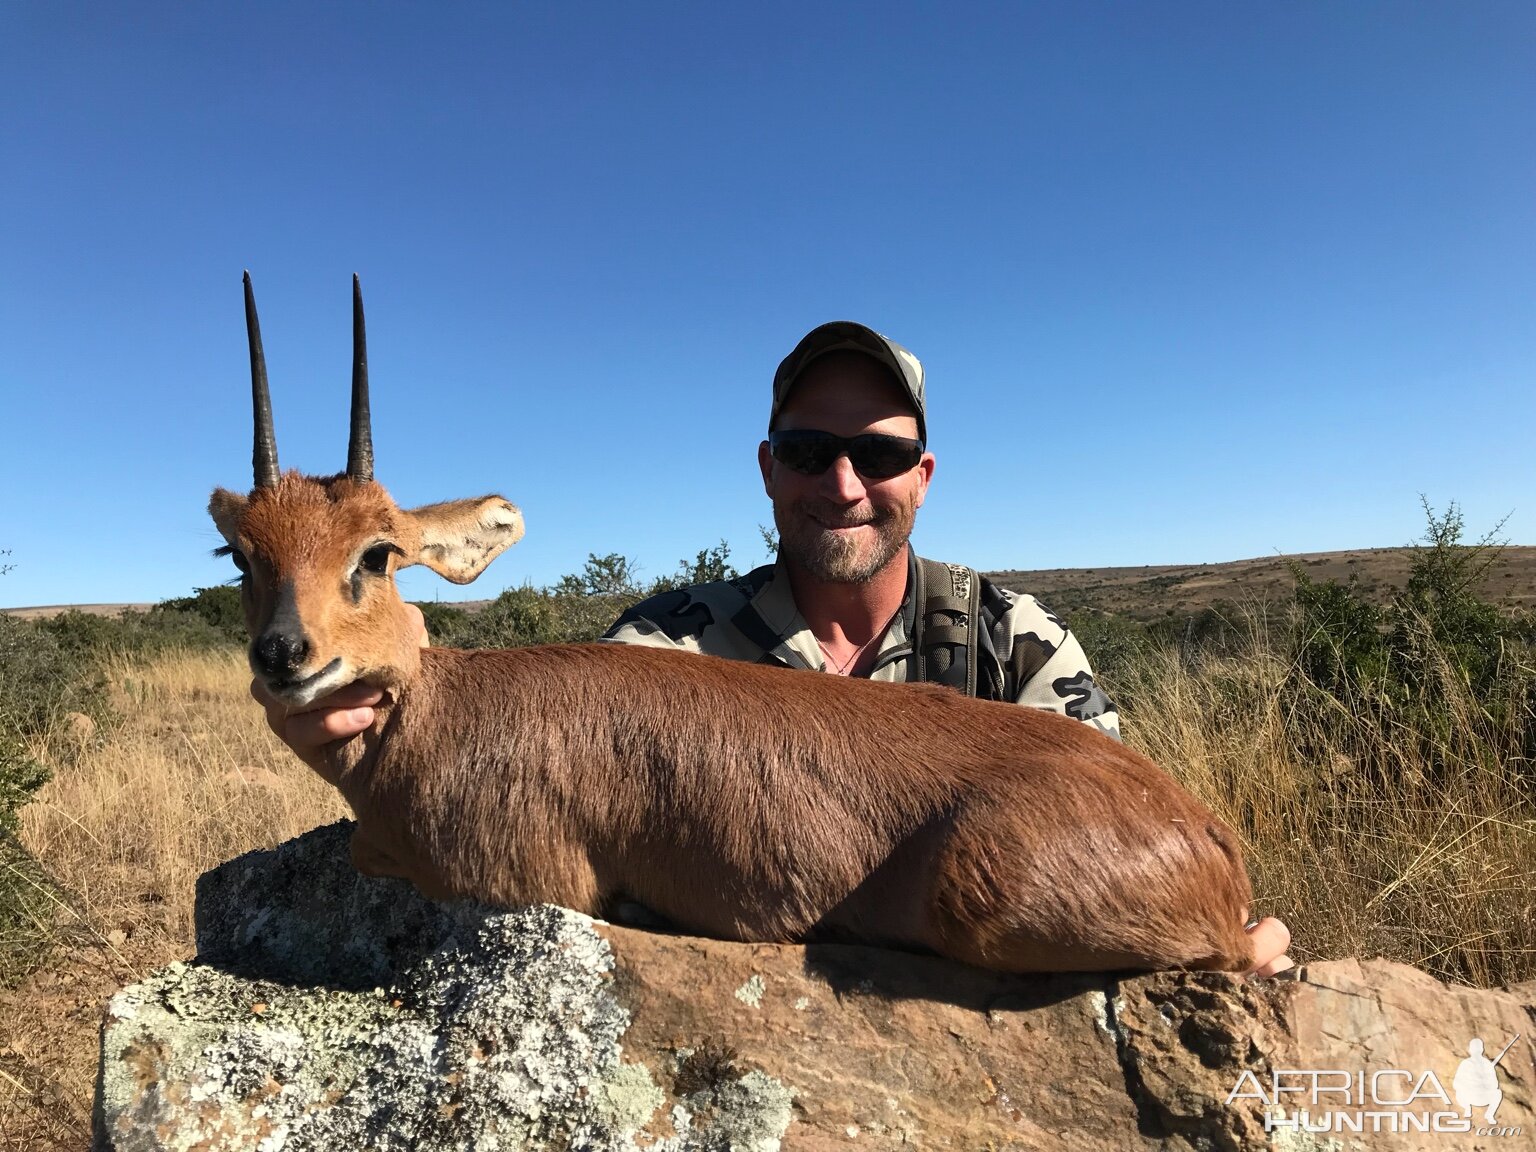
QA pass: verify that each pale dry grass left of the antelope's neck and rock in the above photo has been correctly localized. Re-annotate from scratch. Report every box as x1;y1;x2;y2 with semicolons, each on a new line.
0;653;346;1150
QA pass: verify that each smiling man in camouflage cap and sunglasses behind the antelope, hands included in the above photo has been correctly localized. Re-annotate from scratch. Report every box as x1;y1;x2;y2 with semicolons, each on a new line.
253;321;1290;975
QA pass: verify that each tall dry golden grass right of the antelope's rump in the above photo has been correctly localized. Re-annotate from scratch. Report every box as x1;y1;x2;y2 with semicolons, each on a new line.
1126;621;1536;986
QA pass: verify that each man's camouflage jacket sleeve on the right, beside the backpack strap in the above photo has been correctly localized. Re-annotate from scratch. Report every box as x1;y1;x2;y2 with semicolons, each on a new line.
982;582;1120;740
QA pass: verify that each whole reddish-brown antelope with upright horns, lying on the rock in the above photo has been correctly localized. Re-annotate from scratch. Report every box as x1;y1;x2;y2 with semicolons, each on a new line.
210;278;1253;972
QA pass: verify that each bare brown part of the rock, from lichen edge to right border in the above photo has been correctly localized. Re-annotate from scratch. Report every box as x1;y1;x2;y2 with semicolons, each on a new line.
598;925;1536;1152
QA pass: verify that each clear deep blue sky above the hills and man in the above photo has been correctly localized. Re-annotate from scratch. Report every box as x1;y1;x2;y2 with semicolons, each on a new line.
0;0;1536;605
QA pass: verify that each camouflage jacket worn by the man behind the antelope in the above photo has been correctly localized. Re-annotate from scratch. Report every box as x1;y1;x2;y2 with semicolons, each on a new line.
602;550;1120;739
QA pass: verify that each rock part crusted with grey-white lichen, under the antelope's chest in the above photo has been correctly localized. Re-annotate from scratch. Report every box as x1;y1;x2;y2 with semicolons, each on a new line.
97;825;791;1152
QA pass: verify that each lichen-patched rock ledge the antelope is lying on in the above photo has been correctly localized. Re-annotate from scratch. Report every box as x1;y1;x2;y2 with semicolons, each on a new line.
95;823;1536;1152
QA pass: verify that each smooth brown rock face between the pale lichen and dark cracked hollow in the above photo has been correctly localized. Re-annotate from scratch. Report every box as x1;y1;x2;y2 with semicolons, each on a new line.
598;925;1149;1150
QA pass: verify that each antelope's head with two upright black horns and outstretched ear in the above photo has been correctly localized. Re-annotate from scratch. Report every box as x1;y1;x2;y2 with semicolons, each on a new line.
207;272;522;707
